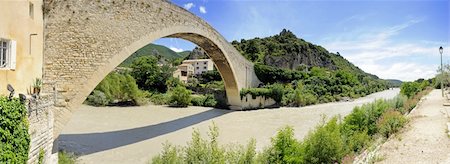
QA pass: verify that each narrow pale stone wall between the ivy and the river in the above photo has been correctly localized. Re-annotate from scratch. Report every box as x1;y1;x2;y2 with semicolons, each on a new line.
26;95;54;163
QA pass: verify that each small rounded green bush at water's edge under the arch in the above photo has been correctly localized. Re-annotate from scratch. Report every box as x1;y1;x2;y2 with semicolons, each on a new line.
169;85;192;107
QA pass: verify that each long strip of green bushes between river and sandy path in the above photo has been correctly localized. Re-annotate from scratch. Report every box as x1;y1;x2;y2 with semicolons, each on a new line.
152;79;431;163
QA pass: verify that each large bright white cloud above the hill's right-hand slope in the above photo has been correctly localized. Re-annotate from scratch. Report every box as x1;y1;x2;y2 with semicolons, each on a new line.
323;19;450;81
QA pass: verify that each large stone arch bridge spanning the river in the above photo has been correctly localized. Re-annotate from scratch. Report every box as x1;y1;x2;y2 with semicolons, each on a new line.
43;0;260;138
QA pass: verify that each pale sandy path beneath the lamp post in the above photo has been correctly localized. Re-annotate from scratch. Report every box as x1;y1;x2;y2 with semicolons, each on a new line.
377;90;450;164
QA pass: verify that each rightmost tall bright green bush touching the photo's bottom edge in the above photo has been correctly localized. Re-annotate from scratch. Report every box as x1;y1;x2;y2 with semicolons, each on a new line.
303;117;345;163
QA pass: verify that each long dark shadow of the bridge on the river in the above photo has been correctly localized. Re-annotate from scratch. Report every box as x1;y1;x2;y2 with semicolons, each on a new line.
53;109;232;155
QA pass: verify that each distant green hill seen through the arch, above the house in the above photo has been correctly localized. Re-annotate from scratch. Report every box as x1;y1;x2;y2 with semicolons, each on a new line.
120;43;190;67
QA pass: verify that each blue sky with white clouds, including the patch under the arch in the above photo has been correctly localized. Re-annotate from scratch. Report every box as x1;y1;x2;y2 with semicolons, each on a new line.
155;0;450;81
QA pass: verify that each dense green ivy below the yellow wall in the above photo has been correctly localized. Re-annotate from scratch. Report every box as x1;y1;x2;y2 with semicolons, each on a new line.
0;96;30;163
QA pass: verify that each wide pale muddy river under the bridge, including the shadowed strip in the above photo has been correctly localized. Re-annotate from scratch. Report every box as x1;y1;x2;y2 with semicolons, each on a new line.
59;89;399;164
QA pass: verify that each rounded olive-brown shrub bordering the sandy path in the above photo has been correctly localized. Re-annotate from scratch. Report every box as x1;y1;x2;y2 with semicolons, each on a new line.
377;110;406;138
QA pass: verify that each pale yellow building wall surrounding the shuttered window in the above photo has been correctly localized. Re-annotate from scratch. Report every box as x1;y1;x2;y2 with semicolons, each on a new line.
0;0;43;96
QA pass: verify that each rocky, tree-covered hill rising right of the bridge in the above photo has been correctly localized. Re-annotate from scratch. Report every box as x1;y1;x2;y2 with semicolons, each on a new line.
232;29;378;79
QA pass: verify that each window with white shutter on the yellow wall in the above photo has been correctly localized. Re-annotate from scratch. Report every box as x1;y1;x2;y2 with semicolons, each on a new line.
0;38;16;69
